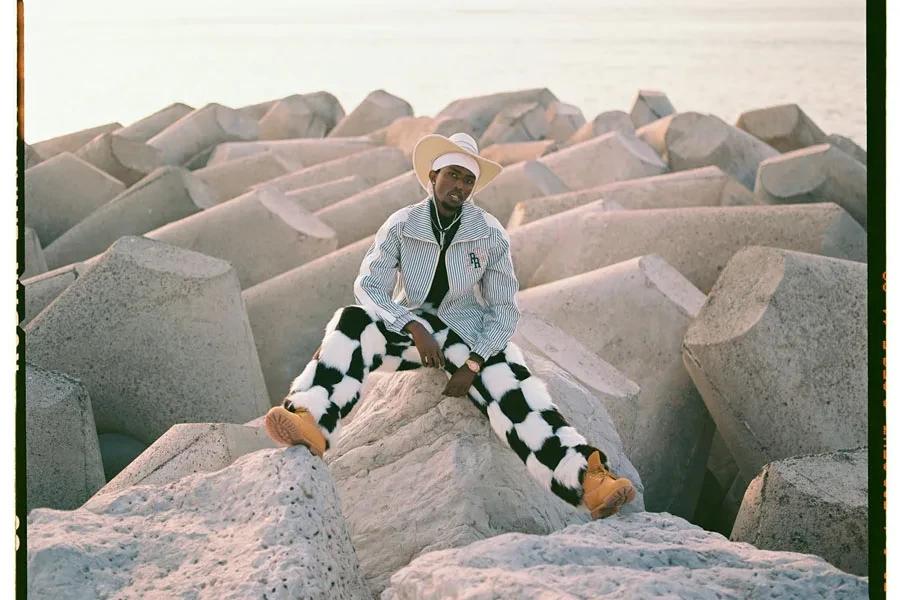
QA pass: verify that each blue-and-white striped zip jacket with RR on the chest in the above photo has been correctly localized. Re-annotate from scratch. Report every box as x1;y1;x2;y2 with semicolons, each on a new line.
353;196;519;359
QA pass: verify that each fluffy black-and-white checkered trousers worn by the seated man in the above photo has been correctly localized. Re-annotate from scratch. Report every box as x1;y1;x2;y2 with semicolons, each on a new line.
284;305;606;506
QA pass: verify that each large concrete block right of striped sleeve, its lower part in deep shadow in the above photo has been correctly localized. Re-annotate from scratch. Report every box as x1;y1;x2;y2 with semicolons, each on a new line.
518;255;715;519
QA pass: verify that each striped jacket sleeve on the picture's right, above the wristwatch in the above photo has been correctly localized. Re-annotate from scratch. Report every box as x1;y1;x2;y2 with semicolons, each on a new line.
472;230;520;360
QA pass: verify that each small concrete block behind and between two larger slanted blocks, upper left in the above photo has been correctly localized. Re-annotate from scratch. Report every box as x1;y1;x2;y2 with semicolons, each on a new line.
193;150;303;202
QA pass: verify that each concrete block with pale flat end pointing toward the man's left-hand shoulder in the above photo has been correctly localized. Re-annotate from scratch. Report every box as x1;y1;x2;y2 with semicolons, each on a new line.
146;188;337;289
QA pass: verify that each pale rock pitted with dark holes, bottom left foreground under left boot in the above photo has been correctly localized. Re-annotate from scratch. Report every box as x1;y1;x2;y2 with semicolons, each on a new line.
27;448;372;600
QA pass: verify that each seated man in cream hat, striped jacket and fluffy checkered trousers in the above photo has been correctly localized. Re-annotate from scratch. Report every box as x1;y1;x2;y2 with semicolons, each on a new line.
266;133;636;519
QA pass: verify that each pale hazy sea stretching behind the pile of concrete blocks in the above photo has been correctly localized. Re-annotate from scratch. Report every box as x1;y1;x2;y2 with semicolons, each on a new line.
25;0;866;148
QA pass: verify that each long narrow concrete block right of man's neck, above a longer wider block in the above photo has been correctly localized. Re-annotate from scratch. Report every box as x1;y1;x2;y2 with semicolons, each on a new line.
508;167;755;229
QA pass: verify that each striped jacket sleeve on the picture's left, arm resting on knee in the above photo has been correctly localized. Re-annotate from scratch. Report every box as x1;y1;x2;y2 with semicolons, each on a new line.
353;215;415;333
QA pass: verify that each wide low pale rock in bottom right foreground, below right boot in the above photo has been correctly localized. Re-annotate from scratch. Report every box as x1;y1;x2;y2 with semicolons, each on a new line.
382;512;869;600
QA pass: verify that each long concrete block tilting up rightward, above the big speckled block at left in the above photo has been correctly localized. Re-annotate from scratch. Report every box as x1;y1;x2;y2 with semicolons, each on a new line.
44;167;218;269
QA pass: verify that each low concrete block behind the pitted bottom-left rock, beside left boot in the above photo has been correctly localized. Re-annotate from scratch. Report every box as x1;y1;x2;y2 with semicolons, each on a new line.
96;423;278;497
